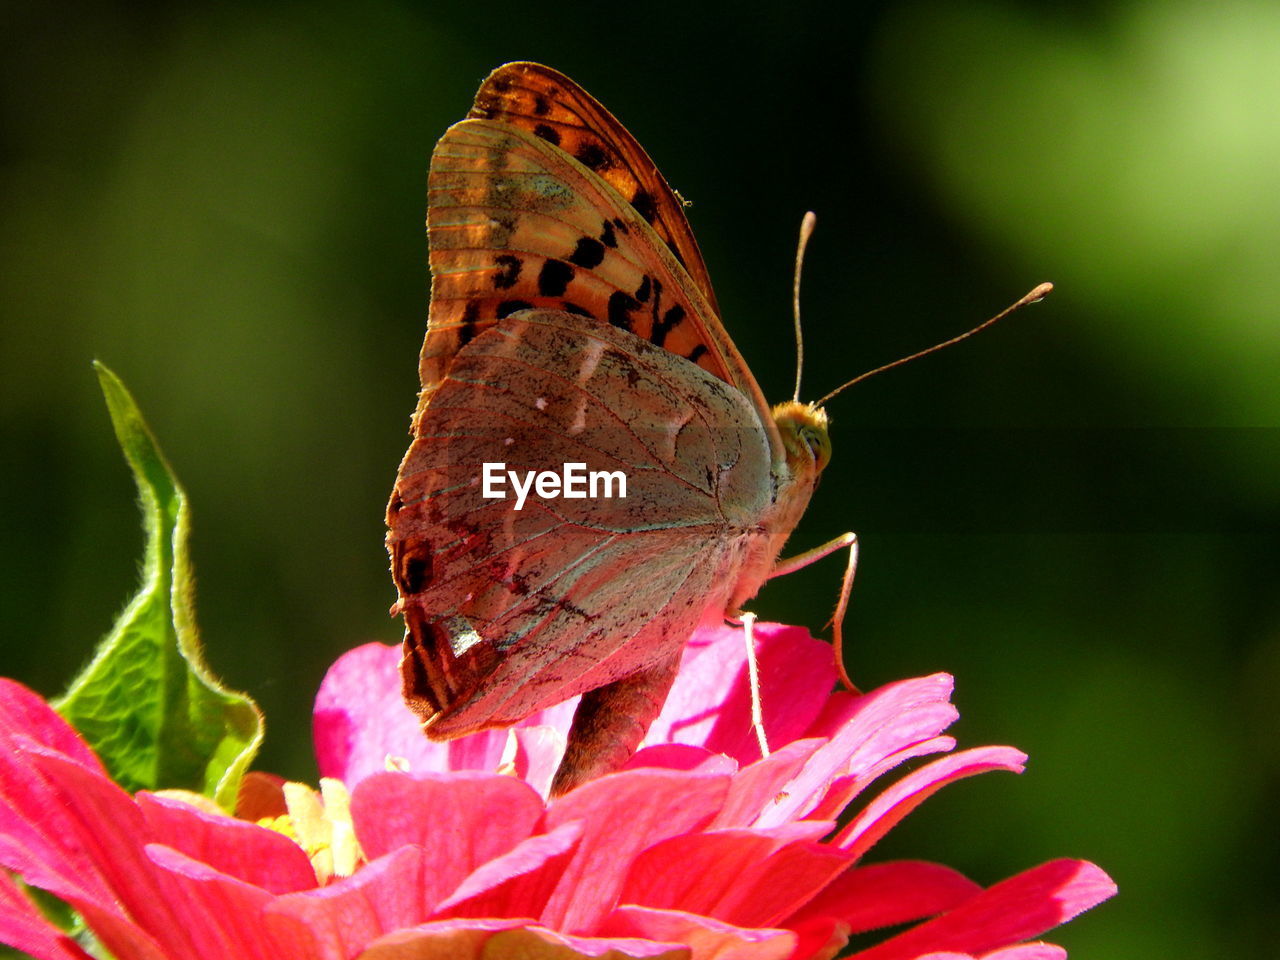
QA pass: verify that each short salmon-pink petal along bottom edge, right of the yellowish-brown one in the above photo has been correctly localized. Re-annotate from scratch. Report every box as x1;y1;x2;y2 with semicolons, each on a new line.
602;906;796;960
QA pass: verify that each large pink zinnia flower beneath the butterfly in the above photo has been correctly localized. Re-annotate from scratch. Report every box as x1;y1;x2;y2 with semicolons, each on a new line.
0;625;1115;960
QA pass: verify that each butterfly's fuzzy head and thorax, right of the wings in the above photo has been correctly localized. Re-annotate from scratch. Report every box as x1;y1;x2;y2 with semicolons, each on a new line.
728;401;831;612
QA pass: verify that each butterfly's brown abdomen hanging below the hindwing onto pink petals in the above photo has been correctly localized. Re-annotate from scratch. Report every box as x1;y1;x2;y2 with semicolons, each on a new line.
552;649;681;796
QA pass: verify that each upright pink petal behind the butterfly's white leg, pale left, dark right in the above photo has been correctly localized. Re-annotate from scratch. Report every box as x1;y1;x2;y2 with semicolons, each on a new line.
644;623;836;764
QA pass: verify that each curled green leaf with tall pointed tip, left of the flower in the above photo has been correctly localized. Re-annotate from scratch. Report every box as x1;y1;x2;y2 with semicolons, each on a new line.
56;364;262;810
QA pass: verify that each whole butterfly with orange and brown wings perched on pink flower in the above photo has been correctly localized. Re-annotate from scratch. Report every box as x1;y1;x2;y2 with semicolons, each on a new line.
387;63;852;794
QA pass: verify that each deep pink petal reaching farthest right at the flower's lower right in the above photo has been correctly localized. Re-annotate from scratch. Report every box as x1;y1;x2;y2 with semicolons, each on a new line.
854;860;1116;960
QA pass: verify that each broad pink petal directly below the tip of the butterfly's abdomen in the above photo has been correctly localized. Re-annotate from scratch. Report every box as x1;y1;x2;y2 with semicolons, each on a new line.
541;768;730;933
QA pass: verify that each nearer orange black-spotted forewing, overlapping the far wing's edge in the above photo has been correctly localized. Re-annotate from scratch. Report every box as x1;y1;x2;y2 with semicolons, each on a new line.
420;120;772;429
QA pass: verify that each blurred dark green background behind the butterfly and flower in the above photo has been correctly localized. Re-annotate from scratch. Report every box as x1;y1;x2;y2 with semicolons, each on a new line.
0;0;1280;960
